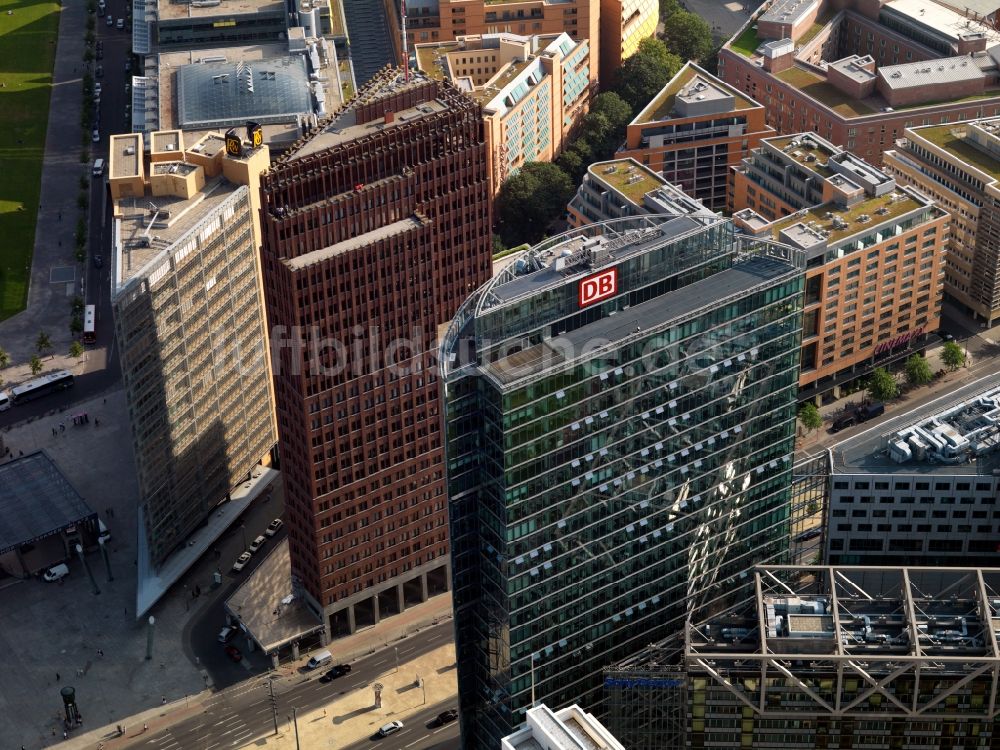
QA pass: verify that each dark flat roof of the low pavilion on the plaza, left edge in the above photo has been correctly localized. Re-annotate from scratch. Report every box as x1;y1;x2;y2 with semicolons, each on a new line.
0;451;96;555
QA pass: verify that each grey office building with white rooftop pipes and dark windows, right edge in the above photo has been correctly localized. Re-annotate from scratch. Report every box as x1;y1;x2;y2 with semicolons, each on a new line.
827;379;1000;566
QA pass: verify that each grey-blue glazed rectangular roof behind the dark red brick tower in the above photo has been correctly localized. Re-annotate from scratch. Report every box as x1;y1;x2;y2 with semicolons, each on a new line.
176;55;313;130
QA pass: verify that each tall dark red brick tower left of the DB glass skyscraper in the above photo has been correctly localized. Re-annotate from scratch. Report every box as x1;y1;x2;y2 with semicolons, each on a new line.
261;70;492;635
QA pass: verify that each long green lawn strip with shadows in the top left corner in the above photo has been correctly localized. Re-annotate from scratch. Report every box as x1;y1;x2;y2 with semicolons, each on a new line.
0;0;61;320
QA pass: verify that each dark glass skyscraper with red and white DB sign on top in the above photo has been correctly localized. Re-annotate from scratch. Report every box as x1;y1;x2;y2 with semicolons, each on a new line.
442;214;804;750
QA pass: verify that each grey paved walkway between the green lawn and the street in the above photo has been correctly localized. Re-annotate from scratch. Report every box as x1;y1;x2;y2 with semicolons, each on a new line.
0;0;90;370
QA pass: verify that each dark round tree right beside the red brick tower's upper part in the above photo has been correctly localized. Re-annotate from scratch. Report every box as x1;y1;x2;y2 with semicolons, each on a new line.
497;162;574;246
